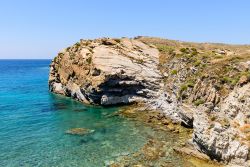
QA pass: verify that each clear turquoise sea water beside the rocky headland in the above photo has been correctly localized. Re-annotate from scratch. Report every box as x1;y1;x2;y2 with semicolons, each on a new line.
0;60;188;167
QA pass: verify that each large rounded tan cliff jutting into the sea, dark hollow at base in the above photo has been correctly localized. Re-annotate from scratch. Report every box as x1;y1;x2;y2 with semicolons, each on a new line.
49;38;161;105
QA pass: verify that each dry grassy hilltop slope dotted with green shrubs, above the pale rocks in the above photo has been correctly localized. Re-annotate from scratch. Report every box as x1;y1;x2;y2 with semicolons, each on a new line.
137;37;250;100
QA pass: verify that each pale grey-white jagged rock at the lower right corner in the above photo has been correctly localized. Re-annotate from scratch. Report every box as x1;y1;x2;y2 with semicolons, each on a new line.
193;84;250;166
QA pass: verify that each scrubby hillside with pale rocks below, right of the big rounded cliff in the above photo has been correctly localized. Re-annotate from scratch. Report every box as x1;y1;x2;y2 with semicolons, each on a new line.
139;37;250;166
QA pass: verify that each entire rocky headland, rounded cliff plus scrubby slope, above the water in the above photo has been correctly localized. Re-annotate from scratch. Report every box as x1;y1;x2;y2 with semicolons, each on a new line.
49;37;250;166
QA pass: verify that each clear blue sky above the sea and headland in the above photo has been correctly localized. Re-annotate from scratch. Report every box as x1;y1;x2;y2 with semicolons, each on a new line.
0;0;250;59
